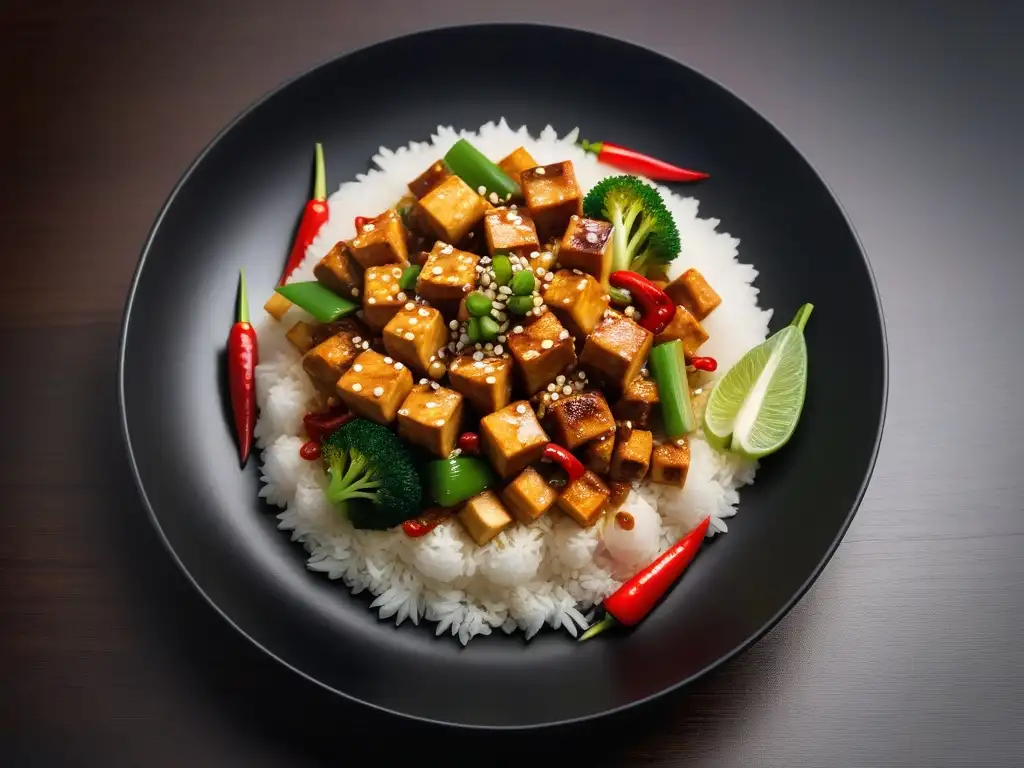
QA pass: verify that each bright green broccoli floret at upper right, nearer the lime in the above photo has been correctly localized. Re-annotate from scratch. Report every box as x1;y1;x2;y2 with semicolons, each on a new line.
583;176;679;274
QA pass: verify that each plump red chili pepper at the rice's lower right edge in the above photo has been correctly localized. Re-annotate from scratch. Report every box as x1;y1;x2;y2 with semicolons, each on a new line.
580;517;711;641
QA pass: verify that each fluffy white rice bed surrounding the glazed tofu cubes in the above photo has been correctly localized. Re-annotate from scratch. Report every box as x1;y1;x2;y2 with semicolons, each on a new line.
254;120;771;644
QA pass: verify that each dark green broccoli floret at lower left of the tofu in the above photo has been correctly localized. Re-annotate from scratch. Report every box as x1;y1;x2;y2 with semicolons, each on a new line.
322;419;423;529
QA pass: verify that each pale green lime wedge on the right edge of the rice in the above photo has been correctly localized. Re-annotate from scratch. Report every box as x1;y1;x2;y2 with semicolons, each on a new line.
705;304;814;459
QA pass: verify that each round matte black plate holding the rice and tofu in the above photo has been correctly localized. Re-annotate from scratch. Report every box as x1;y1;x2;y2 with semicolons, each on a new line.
120;26;886;727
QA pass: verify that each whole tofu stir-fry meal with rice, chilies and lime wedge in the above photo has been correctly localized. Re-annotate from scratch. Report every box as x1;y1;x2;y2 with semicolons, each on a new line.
245;122;810;643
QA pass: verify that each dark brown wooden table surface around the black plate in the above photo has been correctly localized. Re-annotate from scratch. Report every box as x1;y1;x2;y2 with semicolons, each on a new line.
0;0;1024;768
